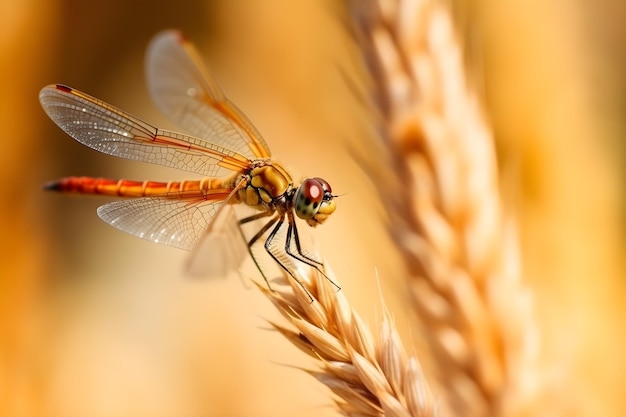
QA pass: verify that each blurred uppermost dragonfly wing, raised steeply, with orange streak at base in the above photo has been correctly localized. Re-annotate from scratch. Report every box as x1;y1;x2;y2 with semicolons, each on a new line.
146;30;270;159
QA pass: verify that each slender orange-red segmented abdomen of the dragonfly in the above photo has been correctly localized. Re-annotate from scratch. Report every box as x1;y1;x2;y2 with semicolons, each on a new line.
44;177;233;200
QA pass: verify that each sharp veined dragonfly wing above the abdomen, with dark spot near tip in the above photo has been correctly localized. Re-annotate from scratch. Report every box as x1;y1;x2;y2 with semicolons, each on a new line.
39;85;250;177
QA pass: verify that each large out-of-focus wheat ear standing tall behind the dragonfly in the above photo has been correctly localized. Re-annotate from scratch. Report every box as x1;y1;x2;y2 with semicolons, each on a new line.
348;0;538;416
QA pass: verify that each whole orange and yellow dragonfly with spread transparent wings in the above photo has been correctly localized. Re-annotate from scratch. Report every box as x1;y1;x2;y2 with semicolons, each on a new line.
39;30;339;288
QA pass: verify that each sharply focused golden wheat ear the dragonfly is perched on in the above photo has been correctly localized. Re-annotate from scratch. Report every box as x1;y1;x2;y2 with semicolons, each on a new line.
258;267;437;417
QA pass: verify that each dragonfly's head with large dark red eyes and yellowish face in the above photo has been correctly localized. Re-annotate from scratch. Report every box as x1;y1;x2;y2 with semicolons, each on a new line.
293;177;335;227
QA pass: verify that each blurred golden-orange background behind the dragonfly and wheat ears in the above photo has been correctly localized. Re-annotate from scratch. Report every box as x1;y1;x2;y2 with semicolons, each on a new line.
0;0;626;417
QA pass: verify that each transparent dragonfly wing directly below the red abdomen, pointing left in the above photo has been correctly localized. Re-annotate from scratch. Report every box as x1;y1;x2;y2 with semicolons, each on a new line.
98;197;224;250
